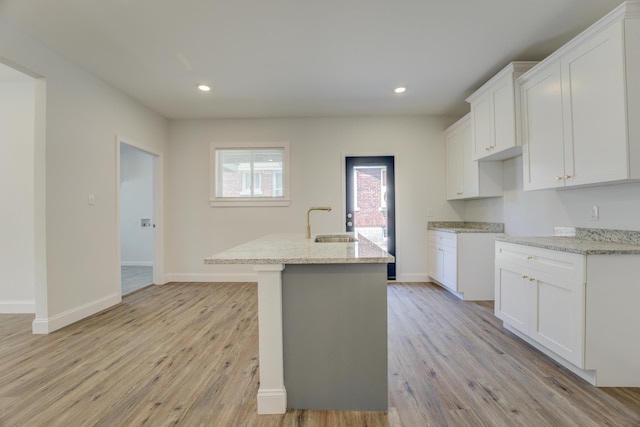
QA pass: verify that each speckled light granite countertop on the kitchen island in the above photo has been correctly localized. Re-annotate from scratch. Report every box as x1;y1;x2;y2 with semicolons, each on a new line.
204;233;395;264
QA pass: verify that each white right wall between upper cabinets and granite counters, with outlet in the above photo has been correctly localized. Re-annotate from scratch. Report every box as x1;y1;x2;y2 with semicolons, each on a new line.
466;157;640;236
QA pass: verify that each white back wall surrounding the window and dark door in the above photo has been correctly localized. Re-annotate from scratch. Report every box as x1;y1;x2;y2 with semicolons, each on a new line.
166;117;464;281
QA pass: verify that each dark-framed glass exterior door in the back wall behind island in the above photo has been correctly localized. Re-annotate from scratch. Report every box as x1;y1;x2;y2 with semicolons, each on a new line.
345;156;396;280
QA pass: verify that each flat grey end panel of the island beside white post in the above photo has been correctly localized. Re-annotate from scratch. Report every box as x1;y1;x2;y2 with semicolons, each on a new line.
282;264;388;411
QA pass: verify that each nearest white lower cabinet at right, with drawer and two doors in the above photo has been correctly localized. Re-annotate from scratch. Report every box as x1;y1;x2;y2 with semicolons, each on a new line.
494;241;640;387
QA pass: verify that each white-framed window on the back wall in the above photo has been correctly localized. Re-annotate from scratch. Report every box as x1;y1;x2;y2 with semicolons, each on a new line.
211;142;289;206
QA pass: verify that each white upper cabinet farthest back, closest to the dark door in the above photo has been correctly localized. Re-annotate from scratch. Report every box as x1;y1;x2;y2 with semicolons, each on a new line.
445;114;502;200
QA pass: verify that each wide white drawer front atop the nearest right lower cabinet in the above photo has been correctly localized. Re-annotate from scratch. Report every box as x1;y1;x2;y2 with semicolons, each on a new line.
496;242;586;282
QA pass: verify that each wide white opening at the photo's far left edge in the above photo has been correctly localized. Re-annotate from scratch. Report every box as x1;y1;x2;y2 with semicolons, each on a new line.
0;58;48;324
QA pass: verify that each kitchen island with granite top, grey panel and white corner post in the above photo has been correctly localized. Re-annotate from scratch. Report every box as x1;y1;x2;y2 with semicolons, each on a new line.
205;234;394;414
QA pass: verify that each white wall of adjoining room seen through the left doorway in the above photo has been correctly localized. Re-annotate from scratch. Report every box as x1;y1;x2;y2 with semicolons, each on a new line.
120;144;154;265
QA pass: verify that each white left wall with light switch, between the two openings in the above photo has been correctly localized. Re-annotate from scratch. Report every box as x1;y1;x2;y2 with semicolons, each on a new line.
0;22;168;332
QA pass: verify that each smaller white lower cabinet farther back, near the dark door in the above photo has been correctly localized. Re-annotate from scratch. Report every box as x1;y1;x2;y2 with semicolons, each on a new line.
427;230;502;301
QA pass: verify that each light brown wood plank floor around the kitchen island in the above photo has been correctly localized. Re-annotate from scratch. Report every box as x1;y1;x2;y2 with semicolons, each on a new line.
0;283;640;427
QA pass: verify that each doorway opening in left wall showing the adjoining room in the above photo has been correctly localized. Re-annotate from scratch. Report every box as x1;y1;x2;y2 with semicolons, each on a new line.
119;141;157;295
